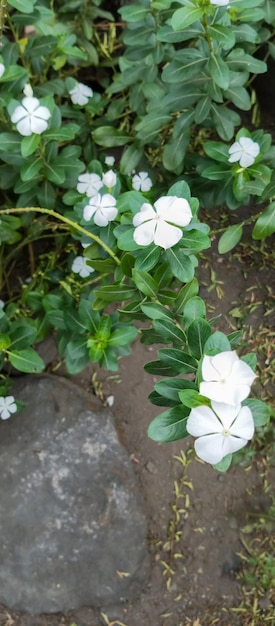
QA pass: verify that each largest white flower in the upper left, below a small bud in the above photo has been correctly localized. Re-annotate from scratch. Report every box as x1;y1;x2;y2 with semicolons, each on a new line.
11;96;51;137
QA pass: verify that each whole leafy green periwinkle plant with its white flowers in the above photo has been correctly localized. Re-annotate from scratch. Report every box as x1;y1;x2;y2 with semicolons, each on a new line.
0;0;275;471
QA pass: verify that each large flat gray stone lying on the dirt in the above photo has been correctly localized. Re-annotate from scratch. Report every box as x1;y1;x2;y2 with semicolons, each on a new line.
0;376;149;613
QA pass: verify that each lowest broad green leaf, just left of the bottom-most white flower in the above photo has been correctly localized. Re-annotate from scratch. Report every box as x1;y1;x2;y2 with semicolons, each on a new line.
148;405;190;442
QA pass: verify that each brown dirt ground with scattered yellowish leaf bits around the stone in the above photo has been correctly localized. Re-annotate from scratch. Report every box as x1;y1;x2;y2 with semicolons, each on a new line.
0;219;275;626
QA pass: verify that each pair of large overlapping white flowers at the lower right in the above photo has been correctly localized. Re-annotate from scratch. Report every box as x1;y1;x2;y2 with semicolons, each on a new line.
187;351;256;464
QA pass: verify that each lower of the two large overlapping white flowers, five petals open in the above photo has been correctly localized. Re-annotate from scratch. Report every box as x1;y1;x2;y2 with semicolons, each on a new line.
186;402;254;464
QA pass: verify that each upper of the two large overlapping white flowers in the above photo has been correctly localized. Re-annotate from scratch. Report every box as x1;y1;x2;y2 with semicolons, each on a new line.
200;351;256;406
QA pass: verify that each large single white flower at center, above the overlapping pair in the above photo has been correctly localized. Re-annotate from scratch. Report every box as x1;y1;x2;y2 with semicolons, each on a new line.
133;196;192;250
